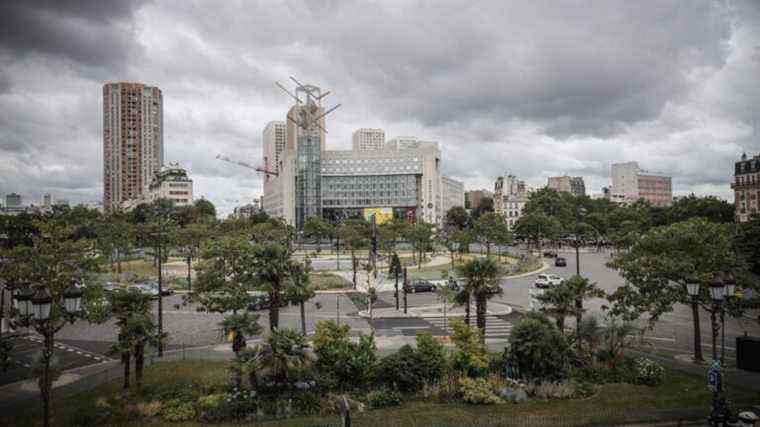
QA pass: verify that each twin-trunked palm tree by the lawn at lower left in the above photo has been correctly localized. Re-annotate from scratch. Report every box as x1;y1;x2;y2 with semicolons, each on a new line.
109;290;165;392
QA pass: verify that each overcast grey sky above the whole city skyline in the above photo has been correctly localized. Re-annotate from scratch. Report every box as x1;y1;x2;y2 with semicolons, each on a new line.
0;0;760;213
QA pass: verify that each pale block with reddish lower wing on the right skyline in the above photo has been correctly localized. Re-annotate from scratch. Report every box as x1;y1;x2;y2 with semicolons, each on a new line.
610;162;673;206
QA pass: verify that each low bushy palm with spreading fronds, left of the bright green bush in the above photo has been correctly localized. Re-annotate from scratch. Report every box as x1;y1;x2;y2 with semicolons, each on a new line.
241;329;312;389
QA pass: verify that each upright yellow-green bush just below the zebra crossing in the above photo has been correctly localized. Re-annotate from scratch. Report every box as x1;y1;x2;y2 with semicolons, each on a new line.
451;319;489;377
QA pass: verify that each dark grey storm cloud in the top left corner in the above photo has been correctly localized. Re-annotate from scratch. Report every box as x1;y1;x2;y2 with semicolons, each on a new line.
0;0;144;70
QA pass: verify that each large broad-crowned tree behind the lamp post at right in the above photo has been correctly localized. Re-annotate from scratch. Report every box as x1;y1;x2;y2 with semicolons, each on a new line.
608;218;744;360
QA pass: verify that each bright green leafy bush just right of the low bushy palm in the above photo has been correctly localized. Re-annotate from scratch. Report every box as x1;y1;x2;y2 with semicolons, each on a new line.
313;320;377;390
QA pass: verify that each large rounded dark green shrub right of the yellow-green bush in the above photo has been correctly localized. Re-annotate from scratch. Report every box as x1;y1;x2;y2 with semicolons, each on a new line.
505;313;570;380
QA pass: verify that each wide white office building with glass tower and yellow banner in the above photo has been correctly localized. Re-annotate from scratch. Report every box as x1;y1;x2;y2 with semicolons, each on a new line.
262;81;463;229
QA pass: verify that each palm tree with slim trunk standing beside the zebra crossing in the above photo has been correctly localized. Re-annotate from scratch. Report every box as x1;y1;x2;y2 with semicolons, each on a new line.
459;257;504;337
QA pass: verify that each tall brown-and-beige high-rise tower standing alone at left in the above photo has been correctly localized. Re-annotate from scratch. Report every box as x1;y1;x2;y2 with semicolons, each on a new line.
103;82;164;211
